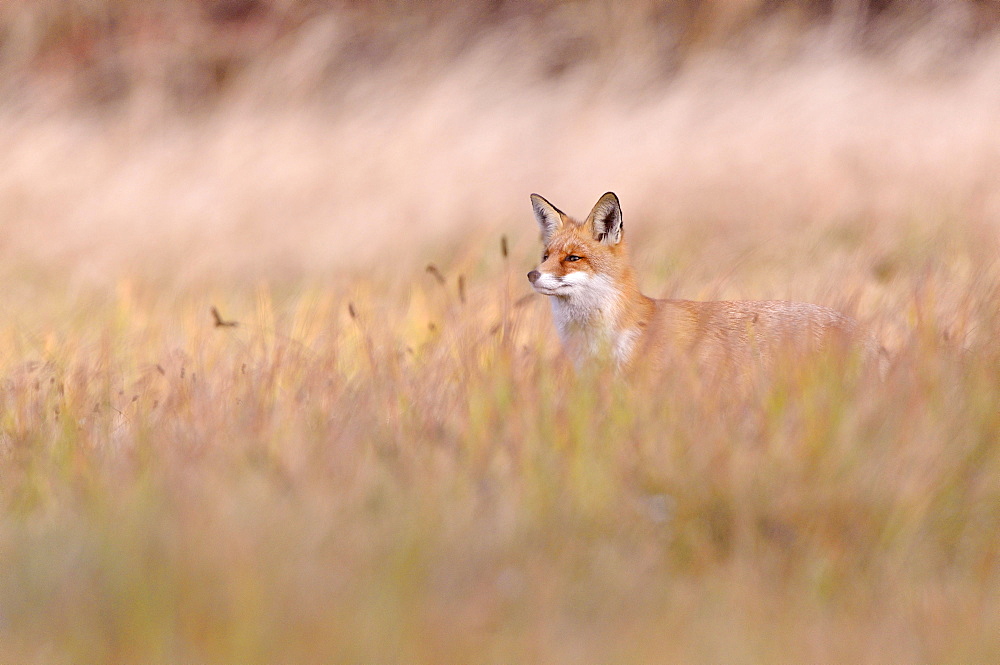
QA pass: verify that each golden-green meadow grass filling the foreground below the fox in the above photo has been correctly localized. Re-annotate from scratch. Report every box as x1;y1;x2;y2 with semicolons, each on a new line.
0;246;1000;663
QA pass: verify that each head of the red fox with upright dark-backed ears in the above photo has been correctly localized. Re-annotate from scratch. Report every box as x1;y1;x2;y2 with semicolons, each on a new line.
528;192;628;300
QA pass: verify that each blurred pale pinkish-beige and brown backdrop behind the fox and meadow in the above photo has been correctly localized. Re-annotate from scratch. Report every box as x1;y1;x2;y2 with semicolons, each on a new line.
0;0;1000;296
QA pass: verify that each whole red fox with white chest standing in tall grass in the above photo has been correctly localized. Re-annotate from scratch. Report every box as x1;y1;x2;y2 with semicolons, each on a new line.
528;192;881;370
